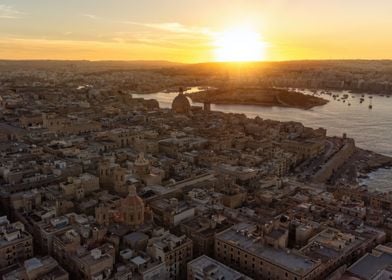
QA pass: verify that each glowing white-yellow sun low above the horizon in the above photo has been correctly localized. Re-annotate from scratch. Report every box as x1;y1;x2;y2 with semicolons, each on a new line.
214;26;267;62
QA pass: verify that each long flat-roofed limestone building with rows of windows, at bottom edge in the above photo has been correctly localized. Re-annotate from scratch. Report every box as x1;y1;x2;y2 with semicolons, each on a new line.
215;223;322;280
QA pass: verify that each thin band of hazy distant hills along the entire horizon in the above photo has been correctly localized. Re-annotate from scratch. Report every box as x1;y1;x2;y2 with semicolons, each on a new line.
0;60;392;75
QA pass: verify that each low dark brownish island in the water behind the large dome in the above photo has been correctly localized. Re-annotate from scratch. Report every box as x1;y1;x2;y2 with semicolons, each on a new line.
187;87;328;110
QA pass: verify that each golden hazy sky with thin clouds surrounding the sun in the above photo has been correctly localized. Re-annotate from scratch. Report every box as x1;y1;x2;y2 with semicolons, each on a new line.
0;0;392;62
